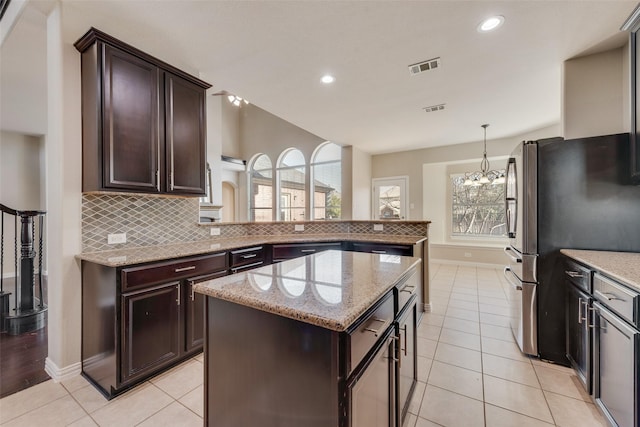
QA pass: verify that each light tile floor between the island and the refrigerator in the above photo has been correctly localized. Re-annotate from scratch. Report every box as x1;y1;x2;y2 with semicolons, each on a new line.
404;264;607;427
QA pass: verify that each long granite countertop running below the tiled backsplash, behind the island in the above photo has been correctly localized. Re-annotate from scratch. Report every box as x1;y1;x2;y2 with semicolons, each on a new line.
76;233;426;267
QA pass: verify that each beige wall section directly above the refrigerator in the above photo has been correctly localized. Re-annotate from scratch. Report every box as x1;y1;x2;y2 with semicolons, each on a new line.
562;47;629;139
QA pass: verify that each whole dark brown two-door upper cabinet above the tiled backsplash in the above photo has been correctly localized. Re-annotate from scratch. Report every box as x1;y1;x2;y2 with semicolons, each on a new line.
75;28;211;196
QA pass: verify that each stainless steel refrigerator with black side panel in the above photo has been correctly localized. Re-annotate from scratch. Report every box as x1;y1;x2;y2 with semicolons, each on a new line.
505;134;640;365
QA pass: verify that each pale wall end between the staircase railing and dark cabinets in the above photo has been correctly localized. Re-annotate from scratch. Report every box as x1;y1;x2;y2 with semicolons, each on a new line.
45;3;82;380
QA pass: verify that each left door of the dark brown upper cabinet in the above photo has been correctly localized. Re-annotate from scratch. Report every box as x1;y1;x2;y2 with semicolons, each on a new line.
102;45;163;192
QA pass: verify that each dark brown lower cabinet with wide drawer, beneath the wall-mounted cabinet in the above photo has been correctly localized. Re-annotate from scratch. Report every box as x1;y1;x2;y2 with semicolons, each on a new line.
82;252;228;399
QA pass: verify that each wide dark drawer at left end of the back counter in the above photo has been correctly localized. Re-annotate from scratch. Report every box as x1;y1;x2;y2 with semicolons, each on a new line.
121;252;227;292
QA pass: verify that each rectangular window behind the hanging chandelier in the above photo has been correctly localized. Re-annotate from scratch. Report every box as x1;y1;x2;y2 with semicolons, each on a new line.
451;171;507;238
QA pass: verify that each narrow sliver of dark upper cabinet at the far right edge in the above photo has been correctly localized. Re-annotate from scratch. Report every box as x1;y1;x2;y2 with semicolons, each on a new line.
622;5;640;185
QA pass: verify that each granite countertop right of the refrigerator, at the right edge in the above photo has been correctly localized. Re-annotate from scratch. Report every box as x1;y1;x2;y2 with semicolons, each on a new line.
560;249;640;291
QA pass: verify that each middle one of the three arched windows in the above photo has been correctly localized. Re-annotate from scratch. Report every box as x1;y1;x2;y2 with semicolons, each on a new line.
277;148;307;221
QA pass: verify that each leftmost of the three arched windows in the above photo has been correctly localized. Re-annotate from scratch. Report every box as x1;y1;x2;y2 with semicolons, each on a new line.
249;154;273;222
